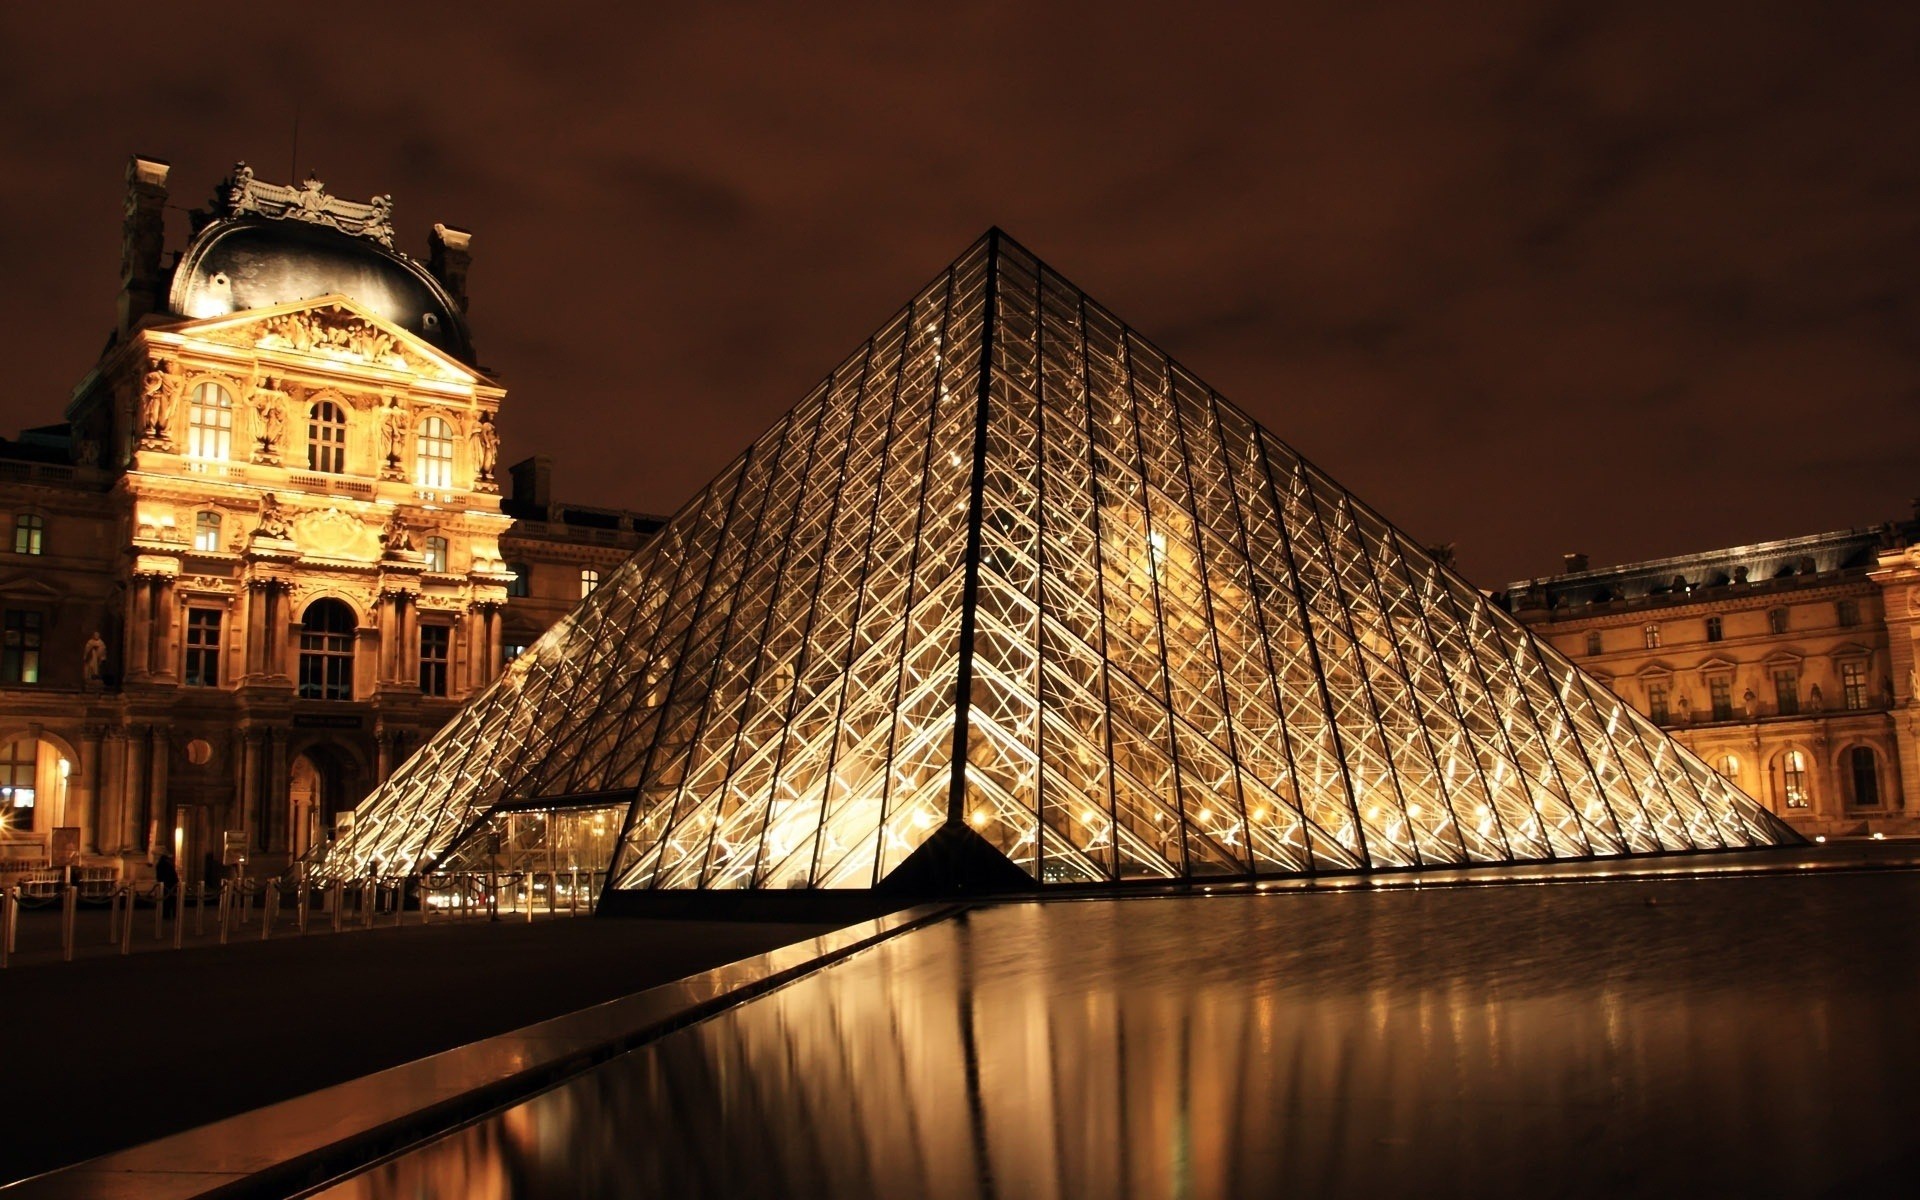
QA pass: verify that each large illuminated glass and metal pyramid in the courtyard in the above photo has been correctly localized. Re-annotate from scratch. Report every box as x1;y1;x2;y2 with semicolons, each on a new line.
326;232;1795;889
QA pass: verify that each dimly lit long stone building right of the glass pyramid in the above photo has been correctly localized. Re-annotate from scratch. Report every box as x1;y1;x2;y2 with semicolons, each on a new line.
1503;520;1920;837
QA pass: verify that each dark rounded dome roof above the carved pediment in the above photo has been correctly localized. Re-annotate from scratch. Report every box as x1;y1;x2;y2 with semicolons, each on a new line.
167;217;474;365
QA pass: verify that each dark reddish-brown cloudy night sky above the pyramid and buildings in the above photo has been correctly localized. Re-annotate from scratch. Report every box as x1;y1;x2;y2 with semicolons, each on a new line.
0;0;1920;588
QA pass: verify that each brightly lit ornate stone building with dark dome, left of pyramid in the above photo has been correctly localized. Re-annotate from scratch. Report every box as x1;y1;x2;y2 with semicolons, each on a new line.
0;157;657;877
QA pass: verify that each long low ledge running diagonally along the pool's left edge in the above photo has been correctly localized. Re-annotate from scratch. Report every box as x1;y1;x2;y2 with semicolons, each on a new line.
0;904;960;1200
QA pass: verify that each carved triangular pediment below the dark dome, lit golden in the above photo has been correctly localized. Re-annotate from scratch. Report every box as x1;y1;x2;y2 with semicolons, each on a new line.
161;294;490;386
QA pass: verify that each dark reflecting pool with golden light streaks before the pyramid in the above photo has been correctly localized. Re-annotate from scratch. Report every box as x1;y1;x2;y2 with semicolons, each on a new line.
324;872;1920;1200
